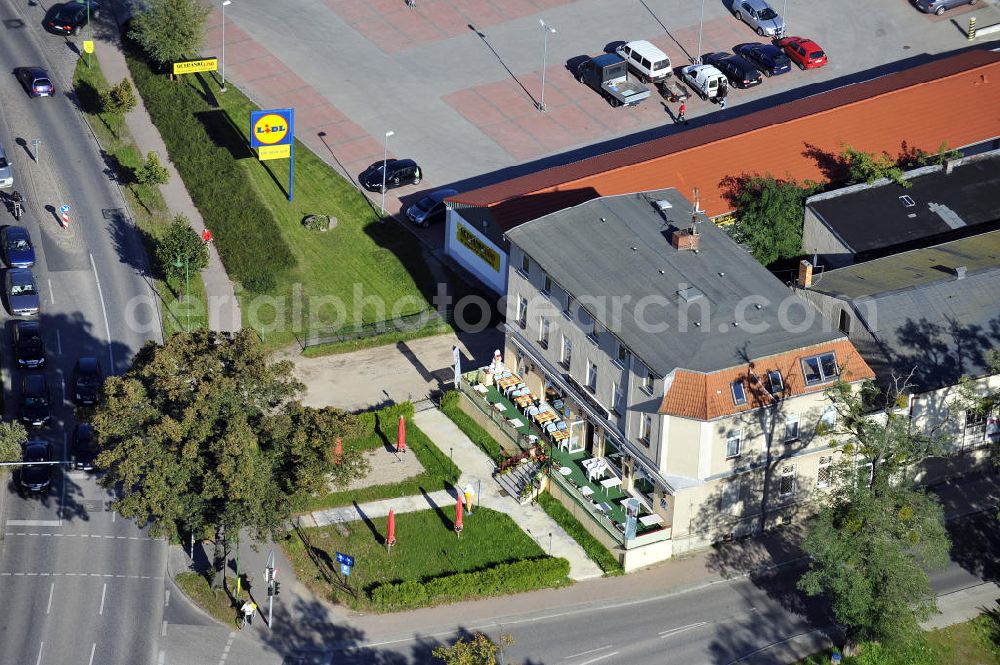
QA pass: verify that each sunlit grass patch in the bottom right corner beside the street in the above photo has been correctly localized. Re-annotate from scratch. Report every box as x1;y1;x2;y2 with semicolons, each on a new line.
798;611;1000;665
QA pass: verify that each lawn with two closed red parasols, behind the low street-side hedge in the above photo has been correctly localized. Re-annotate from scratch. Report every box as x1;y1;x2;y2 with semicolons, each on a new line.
284;505;544;609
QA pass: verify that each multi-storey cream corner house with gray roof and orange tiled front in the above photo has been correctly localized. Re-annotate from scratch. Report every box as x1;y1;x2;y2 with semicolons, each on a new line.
480;189;873;570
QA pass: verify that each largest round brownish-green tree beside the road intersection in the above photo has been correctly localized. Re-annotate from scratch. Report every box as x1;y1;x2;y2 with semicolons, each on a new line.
93;330;364;586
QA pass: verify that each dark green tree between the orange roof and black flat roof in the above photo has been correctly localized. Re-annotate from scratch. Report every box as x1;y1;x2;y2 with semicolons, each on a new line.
723;175;817;266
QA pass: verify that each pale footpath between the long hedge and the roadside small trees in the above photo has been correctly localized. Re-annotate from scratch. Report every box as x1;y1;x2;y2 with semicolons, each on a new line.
95;3;242;331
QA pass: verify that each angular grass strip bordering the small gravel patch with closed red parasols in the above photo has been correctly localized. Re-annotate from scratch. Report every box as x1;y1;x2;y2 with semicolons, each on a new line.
296;404;461;512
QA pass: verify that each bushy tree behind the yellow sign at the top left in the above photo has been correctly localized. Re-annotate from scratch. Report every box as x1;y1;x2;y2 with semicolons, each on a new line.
128;0;212;66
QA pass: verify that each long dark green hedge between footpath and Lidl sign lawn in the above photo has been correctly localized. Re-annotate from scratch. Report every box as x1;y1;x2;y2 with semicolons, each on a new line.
127;43;296;293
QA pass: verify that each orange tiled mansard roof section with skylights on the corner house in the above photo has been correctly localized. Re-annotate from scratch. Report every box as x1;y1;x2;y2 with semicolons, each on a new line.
660;339;875;420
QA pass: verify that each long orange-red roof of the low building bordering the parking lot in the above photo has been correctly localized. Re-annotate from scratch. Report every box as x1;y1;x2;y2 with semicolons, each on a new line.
449;50;1000;230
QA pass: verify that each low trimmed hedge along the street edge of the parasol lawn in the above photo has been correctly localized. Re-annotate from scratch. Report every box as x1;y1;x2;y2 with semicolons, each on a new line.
370;557;569;612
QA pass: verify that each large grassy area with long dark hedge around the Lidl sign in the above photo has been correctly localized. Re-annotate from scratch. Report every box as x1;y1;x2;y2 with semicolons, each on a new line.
123;42;462;347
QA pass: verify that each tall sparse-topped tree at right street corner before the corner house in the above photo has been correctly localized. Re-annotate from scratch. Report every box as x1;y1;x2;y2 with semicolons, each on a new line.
799;382;950;643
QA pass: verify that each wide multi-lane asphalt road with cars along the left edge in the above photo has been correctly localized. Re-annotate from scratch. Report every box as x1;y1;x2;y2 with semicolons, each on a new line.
0;0;167;665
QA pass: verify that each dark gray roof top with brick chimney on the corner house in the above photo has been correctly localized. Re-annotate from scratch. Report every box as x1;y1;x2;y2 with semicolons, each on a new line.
507;189;843;375
